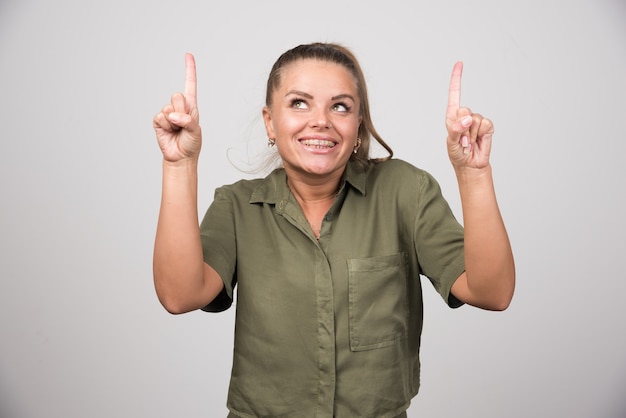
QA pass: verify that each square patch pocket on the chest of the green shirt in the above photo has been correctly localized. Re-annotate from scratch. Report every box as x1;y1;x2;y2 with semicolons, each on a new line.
348;253;408;351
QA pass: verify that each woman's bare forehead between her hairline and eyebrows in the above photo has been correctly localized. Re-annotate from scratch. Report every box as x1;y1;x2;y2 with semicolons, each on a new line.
278;59;357;92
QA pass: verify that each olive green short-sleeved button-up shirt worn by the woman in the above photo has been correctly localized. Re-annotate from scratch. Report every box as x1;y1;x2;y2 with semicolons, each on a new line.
201;160;464;418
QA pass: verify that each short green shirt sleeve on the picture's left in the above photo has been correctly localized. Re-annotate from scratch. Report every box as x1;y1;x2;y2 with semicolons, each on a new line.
200;187;237;312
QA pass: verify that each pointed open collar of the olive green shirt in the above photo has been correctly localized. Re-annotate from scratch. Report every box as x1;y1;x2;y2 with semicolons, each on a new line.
249;160;369;204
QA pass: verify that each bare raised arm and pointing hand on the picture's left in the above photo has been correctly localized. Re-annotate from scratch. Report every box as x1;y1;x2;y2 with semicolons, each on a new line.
153;54;224;314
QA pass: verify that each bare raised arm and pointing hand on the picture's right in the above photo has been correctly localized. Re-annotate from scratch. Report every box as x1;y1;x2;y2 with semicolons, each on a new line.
446;62;515;310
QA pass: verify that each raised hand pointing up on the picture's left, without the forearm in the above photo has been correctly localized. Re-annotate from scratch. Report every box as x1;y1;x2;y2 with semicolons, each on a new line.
152;54;202;162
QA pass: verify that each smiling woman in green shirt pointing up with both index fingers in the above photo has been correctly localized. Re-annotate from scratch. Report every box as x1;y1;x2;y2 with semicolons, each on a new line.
154;43;515;418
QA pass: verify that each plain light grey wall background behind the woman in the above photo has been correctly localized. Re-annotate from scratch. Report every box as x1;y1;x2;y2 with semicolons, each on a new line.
0;0;626;418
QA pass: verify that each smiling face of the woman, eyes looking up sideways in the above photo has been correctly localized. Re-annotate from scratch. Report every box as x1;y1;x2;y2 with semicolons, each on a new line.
263;59;361;181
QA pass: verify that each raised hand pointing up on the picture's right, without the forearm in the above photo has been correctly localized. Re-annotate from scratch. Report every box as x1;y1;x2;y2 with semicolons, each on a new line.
446;62;494;169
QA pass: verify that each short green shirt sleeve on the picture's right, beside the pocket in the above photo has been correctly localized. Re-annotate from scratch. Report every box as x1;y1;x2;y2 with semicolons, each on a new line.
414;172;465;308
